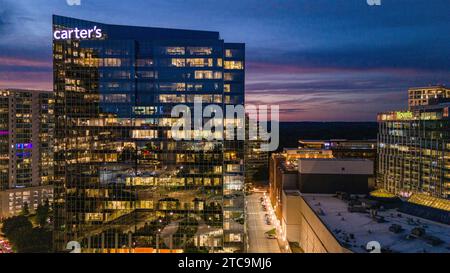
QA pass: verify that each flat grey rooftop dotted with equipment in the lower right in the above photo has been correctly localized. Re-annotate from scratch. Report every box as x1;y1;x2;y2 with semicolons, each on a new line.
300;193;450;253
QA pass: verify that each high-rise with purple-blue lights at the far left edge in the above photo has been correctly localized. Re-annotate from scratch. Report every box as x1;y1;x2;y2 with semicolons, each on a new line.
0;89;54;217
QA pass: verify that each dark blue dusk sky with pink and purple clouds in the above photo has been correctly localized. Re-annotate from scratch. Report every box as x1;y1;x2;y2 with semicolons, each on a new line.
0;0;450;121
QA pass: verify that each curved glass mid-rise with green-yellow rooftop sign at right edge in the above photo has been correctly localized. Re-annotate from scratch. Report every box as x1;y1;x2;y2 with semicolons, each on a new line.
378;92;450;200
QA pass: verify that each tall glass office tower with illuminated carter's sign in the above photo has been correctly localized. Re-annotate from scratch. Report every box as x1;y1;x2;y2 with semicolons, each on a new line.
53;16;245;253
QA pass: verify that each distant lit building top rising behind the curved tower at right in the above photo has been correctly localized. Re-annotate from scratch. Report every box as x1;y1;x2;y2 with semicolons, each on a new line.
408;85;450;109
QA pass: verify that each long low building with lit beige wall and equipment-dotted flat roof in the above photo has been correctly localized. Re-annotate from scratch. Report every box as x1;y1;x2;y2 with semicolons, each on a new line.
281;191;450;253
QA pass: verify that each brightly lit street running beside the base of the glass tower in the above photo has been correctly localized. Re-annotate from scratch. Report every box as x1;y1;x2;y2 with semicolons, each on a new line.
246;193;281;253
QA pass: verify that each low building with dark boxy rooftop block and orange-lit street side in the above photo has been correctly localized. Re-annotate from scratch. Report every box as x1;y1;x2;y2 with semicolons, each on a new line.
269;153;375;220
